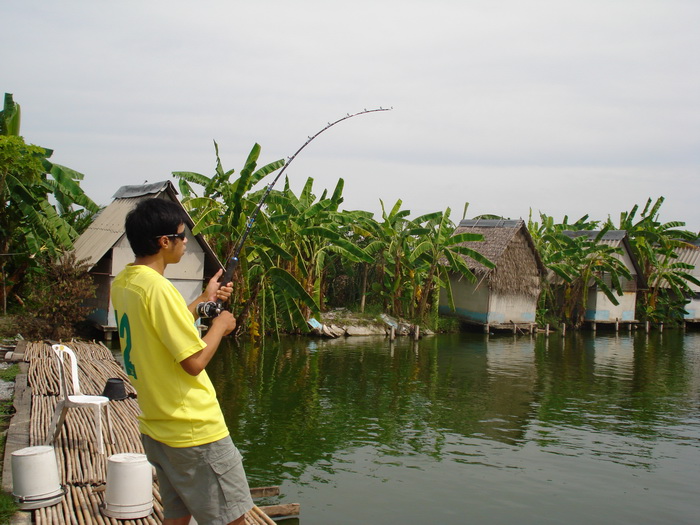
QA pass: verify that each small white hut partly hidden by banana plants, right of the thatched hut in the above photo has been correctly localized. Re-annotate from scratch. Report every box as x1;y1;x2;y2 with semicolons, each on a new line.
563;230;646;330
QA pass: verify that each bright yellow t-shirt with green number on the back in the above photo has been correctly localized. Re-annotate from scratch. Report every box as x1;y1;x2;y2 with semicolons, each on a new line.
112;265;229;447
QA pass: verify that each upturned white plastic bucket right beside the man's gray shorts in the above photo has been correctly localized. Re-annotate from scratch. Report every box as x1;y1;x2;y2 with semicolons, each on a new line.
101;453;153;519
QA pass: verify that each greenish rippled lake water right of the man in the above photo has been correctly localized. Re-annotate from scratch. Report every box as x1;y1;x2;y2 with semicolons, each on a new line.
208;331;700;525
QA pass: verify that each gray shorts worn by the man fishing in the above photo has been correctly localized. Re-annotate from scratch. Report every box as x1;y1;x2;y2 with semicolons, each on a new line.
141;434;253;525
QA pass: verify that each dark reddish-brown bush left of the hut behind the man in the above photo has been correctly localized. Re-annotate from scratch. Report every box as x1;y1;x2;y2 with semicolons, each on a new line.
17;253;95;340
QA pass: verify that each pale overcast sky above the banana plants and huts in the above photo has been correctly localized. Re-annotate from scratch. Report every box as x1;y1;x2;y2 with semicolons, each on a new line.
5;0;700;231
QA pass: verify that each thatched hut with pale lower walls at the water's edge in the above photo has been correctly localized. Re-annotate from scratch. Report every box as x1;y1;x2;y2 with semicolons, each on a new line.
439;219;546;331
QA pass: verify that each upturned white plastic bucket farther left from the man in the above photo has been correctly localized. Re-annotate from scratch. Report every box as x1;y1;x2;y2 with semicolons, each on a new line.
12;446;63;510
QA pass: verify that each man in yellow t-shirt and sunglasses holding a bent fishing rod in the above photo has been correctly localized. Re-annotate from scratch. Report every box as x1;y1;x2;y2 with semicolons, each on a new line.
112;198;253;525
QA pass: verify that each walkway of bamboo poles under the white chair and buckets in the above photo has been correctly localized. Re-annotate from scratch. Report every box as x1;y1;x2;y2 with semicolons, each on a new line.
3;342;288;525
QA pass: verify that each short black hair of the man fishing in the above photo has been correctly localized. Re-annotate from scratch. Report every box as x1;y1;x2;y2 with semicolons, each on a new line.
124;198;187;257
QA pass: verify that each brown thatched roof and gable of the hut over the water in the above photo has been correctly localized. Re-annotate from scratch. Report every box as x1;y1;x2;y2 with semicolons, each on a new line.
454;219;546;296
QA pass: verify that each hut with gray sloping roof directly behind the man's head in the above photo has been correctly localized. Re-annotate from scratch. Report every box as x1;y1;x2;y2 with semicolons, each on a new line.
74;181;222;338
